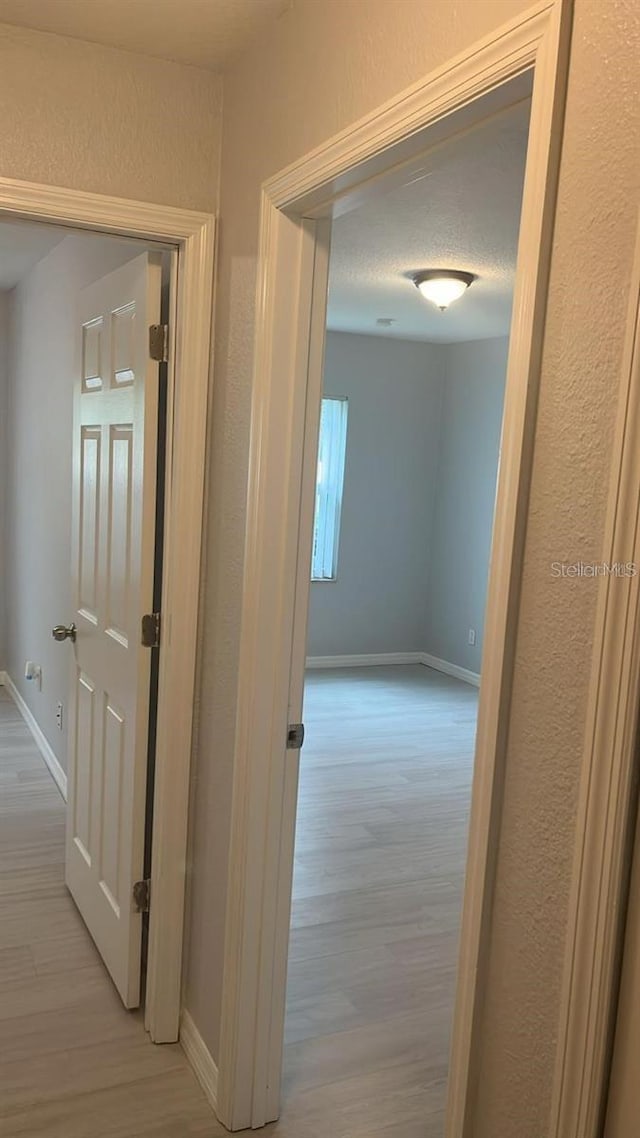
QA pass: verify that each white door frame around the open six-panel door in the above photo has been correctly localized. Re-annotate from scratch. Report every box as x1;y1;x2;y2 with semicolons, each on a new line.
0;179;215;1044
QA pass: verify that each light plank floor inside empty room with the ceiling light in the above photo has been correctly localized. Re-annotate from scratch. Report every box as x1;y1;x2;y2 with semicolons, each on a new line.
274;665;477;1138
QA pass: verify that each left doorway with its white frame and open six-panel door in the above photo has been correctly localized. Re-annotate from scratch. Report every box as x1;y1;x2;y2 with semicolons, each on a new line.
0;182;213;1132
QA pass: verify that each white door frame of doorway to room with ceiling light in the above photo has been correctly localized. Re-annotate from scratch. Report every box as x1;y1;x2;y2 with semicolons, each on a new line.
218;0;571;1138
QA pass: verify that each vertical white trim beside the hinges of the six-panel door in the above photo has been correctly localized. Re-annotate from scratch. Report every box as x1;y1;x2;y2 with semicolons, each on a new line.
145;215;215;1044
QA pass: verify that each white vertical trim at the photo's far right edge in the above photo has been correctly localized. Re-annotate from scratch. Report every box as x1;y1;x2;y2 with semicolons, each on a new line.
549;215;640;1138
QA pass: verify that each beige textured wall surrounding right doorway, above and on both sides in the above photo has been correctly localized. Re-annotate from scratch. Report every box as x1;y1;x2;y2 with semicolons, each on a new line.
187;0;638;1138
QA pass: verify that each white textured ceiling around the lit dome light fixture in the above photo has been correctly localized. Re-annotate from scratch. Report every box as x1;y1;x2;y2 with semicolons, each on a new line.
328;102;530;344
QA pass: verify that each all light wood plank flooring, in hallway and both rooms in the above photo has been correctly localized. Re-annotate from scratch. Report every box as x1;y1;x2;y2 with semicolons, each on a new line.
0;666;477;1138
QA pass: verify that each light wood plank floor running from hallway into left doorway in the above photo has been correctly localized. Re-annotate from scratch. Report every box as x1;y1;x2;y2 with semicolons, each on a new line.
0;687;218;1138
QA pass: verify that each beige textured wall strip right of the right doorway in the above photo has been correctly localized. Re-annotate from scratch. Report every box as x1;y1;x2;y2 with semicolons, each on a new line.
469;0;640;1138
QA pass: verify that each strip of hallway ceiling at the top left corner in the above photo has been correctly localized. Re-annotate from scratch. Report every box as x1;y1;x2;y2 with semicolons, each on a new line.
0;0;286;71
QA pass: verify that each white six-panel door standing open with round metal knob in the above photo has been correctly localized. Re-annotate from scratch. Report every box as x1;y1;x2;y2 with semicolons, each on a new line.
66;254;161;1007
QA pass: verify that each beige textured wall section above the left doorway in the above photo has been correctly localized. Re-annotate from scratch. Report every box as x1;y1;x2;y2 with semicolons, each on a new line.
0;24;222;211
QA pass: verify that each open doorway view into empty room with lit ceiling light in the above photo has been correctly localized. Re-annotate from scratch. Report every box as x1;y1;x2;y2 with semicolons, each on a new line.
282;99;531;1135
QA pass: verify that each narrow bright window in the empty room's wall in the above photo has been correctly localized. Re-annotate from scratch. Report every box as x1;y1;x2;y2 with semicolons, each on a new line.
311;399;348;580
